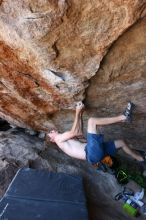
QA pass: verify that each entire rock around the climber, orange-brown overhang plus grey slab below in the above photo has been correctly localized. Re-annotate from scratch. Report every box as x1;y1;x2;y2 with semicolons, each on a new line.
0;3;146;220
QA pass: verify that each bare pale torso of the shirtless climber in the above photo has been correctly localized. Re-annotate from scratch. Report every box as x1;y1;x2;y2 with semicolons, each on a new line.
56;138;87;160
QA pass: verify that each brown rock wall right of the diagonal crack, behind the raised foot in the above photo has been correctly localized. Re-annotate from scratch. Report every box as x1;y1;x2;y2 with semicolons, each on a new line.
86;18;146;149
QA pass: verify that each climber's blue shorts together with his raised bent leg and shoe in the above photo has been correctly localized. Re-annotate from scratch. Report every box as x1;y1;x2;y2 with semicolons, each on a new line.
85;102;133;164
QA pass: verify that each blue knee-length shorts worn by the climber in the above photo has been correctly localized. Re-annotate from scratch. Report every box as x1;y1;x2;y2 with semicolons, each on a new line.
85;133;117;164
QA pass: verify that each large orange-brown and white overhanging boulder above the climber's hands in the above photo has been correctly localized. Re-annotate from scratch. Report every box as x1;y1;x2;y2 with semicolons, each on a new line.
0;0;146;129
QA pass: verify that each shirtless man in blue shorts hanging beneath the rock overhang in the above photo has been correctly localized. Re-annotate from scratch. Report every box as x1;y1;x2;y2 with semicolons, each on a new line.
47;102;144;164
